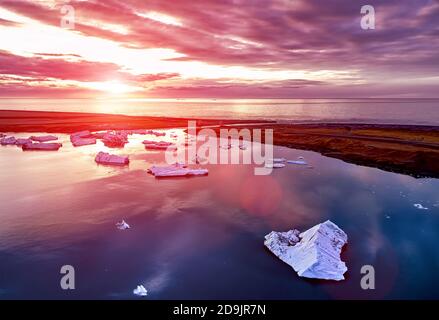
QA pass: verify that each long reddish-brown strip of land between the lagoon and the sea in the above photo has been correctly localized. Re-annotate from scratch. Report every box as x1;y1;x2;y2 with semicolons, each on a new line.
0;110;439;178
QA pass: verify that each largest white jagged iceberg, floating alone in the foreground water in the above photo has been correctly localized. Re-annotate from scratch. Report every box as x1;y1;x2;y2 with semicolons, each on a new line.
264;220;348;281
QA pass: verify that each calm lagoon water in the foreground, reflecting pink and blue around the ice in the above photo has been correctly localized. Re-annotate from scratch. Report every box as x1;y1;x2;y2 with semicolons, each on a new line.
0;129;439;299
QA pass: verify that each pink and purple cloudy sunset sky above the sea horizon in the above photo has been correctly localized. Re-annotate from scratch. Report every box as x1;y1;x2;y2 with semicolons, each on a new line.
0;0;439;98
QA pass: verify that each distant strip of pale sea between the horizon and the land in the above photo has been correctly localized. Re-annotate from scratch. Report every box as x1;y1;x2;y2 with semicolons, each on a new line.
0;98;439;125
